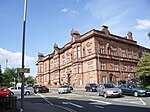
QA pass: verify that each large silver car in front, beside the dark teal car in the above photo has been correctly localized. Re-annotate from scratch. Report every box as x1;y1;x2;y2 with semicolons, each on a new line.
97;83;122;98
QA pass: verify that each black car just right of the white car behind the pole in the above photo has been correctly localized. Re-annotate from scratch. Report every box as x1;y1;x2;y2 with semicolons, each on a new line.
33;85;49;93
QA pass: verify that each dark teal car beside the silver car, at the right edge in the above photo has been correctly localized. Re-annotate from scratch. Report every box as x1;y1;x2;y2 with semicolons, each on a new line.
119;83;150;97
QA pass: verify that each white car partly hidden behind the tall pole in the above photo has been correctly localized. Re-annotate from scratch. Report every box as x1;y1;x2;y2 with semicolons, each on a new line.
8;87;33;95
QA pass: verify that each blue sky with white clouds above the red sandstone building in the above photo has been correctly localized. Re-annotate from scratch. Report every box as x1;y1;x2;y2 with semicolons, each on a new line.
0;0;150;76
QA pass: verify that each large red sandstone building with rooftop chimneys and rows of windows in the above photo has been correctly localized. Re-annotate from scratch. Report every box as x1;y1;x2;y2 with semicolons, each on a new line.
36;26;150;87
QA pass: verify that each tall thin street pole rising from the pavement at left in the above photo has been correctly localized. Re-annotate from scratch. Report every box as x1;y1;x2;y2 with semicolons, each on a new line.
21;0;27;112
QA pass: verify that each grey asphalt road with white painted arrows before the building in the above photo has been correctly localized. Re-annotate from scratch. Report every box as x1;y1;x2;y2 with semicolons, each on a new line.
16;89;150;112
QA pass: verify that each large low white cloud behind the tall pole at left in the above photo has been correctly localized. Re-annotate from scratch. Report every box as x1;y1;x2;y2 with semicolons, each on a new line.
0;48;36;74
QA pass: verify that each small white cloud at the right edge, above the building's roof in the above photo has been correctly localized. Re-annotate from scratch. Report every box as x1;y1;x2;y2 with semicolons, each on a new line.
135;19;150;30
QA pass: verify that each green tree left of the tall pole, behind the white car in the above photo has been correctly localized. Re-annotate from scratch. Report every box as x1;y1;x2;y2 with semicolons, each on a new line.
2;68;17;87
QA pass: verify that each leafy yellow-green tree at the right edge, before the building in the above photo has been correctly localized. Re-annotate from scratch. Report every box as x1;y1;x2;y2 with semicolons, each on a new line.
136;53;150;84
